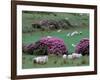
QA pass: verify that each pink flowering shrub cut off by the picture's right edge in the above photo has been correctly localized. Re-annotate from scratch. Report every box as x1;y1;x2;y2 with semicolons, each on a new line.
75;38;89;55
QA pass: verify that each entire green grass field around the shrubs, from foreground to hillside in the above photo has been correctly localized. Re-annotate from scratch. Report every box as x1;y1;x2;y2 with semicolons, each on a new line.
22;12;89;69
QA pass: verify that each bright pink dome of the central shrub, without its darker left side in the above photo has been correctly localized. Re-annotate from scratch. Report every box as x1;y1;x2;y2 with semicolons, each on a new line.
38;37;68;55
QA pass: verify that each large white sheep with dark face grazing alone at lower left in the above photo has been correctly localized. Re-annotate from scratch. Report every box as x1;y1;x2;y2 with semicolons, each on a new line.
33;56;48;64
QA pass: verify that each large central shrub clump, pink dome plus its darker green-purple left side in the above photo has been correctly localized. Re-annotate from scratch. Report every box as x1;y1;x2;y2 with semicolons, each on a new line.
24;37;68;55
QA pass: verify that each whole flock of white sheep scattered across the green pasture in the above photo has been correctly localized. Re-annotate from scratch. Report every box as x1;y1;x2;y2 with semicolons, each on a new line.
33;30;82;64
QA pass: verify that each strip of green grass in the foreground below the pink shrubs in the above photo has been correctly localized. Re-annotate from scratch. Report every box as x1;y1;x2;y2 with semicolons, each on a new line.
22;54;89;69
